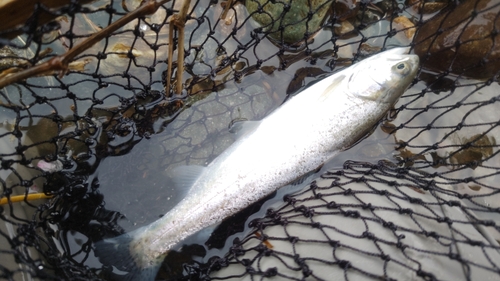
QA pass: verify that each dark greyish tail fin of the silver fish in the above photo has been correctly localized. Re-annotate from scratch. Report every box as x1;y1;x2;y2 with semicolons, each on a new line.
94;229;165;281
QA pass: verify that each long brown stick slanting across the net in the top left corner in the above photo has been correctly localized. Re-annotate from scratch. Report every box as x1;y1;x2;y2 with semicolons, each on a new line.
0;0;170;89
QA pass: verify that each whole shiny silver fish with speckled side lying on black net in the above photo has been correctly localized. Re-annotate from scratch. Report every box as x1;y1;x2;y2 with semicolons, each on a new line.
96;48;419;280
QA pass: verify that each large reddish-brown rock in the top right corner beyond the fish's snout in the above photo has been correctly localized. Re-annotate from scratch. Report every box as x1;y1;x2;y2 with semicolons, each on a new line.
414;0;500;79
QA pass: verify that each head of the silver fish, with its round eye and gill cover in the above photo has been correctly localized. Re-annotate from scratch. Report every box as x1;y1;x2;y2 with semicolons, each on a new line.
347;48;419;104
